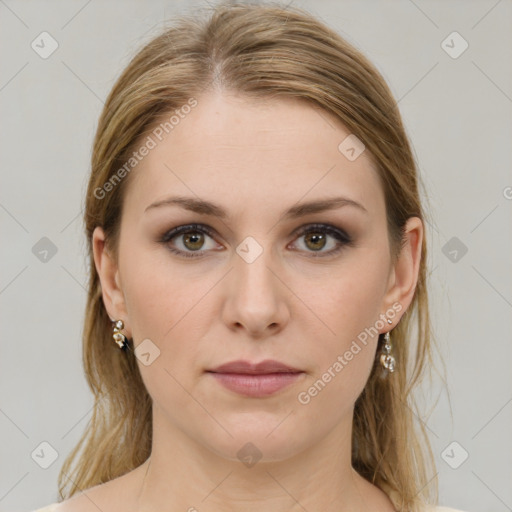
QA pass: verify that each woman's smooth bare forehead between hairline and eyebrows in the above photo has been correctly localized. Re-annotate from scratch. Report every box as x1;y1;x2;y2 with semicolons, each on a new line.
122;93;384;219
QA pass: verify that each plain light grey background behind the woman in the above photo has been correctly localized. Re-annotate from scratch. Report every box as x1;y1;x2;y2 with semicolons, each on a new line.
0;0;512;512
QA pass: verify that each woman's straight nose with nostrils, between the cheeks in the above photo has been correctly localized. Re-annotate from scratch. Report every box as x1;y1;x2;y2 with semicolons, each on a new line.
223;246;290;338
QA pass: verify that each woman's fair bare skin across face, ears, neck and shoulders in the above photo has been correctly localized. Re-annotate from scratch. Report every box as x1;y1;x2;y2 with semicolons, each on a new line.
61;92;423;512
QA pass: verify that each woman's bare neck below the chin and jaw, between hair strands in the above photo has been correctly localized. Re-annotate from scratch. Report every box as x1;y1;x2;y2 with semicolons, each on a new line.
132;411;384;512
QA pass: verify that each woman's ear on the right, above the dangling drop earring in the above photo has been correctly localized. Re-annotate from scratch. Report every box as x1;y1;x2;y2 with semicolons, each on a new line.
382;217;423;332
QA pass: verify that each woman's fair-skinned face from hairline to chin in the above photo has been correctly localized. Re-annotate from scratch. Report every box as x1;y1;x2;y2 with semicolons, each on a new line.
94;93;421;461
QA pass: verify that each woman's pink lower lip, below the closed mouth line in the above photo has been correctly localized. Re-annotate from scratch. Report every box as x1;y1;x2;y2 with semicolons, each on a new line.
209;372;304;397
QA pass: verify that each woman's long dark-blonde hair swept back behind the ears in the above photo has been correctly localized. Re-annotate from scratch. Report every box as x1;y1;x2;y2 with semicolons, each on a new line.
59;3;438;511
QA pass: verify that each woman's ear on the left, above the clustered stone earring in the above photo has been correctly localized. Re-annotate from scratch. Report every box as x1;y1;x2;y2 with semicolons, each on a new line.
92;226;128;331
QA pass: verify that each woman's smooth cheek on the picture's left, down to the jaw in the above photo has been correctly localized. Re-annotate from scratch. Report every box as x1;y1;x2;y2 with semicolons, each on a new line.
119;252;205;416
